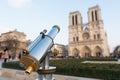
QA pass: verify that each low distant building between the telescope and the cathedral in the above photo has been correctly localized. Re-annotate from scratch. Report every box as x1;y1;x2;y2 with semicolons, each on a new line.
51;44;68;57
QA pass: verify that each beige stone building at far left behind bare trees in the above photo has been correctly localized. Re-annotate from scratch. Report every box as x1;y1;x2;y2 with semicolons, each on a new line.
0;30;30;58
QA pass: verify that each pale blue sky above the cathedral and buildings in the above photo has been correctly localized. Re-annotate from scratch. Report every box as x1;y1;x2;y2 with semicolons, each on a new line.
0;0;120;51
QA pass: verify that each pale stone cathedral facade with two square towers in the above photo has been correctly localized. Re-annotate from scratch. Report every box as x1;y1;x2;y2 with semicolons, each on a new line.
69;5;109;57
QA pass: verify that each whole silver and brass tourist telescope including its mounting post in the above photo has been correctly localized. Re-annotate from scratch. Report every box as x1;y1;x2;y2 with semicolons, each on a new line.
20;25;60;80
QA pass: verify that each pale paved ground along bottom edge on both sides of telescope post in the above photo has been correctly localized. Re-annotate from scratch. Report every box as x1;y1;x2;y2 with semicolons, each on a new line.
0;68;100;80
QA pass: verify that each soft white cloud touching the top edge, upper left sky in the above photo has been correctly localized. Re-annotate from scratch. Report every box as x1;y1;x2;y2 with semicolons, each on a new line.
8;0;32;8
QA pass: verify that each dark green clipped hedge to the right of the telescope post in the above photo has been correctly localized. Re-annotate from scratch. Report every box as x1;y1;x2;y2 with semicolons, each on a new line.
50;59;120;80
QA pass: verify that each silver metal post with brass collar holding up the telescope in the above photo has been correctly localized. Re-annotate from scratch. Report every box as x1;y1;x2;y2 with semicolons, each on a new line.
36;50;56;80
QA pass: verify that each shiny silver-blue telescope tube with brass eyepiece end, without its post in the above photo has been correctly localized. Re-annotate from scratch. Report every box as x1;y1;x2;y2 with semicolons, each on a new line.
20;25;60;74
